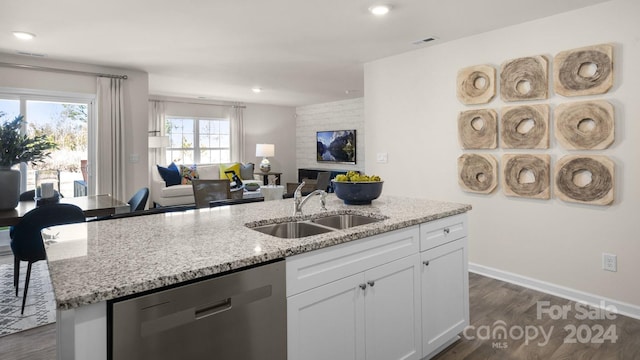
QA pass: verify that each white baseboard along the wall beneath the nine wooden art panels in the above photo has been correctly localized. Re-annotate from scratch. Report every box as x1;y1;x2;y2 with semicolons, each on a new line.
469;263;640;320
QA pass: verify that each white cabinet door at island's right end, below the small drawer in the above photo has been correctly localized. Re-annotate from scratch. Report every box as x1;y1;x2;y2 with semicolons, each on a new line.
421;237;469;356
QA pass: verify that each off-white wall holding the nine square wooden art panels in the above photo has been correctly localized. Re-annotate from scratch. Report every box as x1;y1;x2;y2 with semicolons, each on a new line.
365;0;640;306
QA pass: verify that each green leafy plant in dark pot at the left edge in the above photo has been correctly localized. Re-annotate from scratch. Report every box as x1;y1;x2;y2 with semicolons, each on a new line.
0;112;57;210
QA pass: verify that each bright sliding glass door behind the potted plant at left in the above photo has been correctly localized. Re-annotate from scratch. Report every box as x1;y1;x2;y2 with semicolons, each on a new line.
0;93;95;197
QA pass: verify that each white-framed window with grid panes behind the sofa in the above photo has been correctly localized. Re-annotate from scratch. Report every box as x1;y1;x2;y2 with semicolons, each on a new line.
166;117;231;164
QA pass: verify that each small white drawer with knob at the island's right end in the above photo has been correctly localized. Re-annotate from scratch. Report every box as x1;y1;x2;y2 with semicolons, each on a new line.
420;213;467;251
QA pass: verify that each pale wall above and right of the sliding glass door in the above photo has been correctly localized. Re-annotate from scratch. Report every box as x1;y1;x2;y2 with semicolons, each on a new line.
0;53;149;201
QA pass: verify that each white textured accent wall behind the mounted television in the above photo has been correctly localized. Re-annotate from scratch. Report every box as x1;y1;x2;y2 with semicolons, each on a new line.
296;98;366;171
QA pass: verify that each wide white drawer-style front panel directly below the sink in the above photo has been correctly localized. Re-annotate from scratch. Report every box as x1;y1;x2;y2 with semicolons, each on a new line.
286;225;420;296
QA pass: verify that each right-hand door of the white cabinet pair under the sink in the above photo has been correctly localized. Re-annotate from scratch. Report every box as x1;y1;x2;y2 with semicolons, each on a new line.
362;254;422;360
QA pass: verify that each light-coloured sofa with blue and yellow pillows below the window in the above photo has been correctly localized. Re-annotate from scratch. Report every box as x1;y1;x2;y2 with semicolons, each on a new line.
151;163;262;207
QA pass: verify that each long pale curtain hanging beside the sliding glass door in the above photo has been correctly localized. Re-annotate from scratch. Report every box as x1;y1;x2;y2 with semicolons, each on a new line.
97;77;128;202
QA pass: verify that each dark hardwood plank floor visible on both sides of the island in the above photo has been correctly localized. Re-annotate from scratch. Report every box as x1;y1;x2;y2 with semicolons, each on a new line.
0;273;640;360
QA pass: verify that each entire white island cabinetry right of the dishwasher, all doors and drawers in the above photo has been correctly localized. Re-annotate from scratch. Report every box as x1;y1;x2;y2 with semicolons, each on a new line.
286;214;469;360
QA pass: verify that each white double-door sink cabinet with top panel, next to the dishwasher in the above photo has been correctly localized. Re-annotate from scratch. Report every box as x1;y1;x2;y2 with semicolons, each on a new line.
287;226;422;360
